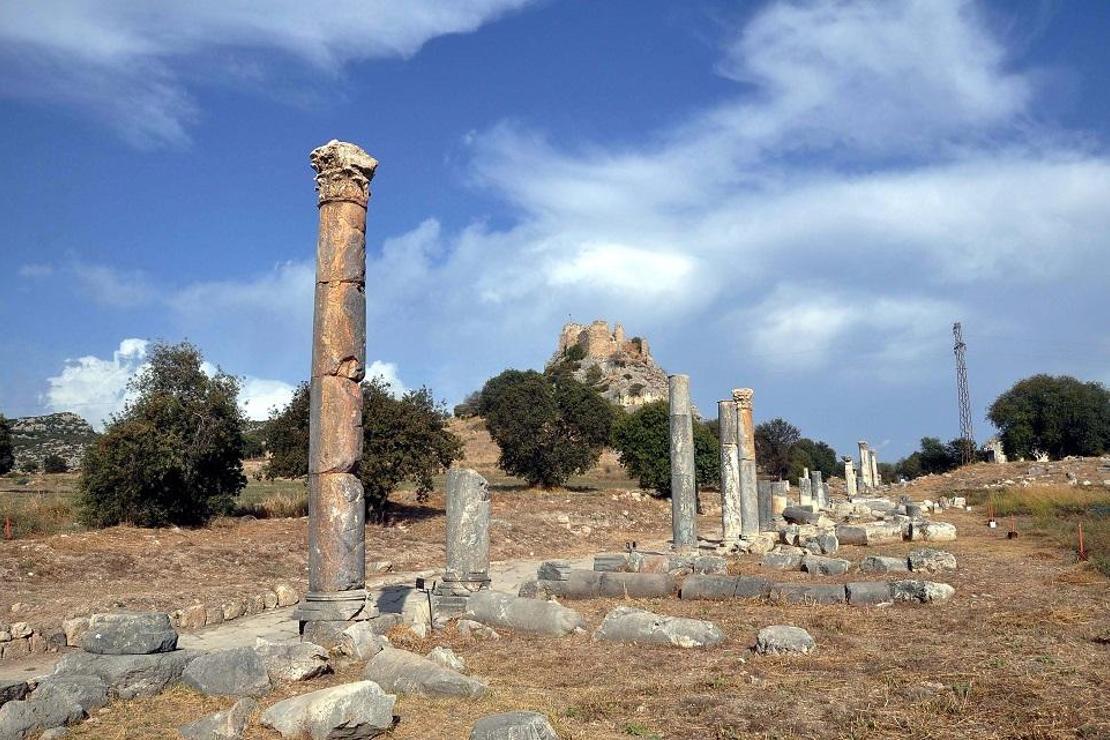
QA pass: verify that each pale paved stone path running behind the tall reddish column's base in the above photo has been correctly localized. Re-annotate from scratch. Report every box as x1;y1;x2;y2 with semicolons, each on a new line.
0;555;593;680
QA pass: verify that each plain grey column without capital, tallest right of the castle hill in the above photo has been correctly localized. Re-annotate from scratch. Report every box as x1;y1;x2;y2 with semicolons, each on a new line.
667;375;697;550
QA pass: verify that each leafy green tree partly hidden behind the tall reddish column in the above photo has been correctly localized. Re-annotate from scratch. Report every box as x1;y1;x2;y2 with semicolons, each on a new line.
264;378;463;520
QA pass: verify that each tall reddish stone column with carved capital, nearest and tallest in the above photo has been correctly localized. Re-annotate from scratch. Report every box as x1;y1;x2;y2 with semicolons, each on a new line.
296;140;377;632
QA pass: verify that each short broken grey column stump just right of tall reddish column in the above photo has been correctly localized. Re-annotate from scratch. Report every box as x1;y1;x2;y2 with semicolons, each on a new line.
435;468;491;614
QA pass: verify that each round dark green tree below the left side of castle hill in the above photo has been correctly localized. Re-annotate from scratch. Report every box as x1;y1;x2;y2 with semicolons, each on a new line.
481;369;613;488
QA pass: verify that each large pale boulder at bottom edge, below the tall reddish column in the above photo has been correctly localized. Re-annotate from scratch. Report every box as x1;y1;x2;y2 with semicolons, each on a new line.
262;681;396;740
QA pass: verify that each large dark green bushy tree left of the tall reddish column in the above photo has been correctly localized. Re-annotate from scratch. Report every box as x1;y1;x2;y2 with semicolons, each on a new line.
79;342;246;527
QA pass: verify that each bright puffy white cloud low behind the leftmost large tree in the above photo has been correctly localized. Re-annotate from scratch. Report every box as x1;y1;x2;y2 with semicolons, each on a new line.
44;338;147;429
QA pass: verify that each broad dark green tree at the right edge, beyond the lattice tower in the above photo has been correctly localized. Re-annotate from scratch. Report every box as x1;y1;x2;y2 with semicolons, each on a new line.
987;375;1110;458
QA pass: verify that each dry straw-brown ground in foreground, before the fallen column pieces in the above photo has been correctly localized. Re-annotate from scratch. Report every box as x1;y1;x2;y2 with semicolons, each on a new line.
62;505;1110;740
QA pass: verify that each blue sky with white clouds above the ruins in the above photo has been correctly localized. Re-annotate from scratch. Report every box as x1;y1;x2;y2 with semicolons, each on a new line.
0;0;1110;460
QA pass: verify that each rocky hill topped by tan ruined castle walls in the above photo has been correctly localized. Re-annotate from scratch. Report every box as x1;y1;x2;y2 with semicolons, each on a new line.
547;321;667;409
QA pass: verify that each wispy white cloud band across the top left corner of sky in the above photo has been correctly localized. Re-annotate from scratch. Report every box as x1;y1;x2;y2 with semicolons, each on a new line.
0;0;537;145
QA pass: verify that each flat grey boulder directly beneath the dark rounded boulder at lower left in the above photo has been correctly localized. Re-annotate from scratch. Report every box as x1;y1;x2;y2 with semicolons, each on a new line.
52;650;201;699
